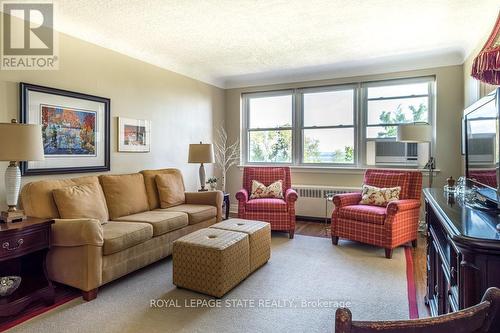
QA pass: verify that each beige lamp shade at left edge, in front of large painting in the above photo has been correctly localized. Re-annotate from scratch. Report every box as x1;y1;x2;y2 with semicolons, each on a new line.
0;123;44;162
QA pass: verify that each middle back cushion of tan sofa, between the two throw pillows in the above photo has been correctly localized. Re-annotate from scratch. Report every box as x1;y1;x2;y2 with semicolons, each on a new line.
99;173;149;220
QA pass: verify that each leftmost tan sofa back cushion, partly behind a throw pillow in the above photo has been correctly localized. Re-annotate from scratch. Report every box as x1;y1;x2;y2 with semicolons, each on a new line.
21;176;99;219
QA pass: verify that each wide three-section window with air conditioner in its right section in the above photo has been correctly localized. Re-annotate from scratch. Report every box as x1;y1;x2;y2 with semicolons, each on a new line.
242;77;434;167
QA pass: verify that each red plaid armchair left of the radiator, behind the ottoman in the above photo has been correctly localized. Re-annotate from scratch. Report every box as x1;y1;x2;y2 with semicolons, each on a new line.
236;167;297;238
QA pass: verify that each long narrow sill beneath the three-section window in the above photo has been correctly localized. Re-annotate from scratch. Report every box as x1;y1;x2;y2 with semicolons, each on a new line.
238;164;441;175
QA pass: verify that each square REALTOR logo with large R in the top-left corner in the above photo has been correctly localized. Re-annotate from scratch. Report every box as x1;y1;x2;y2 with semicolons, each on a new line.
0;1;58;70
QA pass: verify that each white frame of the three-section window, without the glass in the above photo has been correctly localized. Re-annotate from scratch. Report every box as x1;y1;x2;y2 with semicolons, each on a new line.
240;75;436;169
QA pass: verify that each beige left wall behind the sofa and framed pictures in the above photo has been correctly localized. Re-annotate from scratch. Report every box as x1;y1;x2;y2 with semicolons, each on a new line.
0;35;224;209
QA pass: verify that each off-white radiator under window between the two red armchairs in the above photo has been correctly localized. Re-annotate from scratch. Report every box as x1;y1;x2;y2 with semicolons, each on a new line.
292;185;360;219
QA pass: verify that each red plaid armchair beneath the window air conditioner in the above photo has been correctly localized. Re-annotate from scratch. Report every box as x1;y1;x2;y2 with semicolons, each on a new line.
332;169;422;259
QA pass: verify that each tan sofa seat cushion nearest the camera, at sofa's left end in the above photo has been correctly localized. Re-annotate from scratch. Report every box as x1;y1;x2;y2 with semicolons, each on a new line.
102;222;153;256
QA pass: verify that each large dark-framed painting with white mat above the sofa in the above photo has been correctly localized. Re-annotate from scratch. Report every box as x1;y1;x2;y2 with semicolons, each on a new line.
20;83;110;175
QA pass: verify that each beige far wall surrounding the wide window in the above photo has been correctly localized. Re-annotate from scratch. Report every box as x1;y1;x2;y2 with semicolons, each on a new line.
225;65;464;205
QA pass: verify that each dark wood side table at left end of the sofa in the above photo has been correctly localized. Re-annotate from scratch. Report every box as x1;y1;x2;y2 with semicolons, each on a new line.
0;218;54;317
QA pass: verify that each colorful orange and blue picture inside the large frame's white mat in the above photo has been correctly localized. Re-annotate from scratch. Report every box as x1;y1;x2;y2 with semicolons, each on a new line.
41;105;97;156
